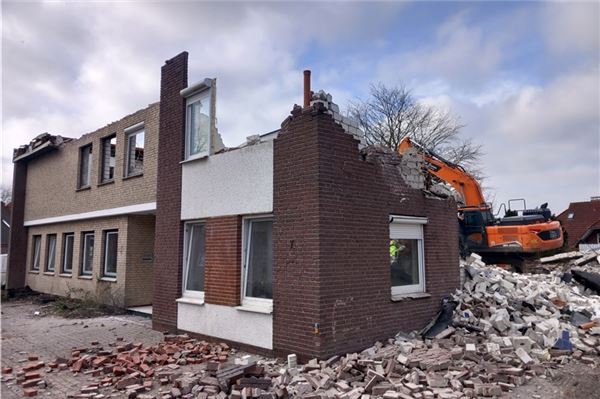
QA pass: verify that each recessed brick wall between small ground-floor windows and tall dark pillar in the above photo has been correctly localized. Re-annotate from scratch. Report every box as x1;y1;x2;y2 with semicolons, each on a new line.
125;215;155;306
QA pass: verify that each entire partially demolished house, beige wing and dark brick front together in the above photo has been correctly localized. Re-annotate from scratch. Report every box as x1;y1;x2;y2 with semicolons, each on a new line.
10;53;459;358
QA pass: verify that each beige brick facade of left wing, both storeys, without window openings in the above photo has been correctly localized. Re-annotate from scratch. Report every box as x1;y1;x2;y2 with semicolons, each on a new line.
24;103;159;307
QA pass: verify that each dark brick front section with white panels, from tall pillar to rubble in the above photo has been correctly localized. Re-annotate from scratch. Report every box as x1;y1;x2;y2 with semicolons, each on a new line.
153;53;458;358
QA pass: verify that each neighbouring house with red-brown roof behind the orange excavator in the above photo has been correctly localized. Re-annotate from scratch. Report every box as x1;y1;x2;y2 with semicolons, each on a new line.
557;197;600;250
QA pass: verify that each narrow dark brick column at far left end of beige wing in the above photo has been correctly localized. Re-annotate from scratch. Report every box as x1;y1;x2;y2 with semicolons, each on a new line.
6;162;27;289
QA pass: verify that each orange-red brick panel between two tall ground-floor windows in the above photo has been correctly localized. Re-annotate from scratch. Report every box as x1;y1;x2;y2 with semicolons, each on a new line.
204;216;242;306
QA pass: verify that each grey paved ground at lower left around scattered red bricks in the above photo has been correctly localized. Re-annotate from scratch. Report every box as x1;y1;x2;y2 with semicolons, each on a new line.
0;300;163;399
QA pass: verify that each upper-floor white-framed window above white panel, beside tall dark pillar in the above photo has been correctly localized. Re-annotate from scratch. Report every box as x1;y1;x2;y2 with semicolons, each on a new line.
185;90;211;158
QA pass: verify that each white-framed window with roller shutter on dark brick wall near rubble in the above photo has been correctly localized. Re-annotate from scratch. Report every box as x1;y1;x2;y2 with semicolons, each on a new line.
390;216;427;295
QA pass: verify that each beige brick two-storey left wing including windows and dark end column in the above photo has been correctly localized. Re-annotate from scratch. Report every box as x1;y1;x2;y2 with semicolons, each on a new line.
8;103;159;306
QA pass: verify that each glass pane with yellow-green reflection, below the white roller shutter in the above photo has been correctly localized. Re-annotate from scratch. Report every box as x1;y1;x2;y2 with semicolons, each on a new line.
390;240;420;287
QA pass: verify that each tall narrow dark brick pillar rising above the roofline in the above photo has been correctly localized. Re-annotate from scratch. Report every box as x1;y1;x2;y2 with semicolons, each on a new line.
152;52;188;330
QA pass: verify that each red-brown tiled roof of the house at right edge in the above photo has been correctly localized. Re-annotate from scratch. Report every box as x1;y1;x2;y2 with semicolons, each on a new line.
557;200;600;247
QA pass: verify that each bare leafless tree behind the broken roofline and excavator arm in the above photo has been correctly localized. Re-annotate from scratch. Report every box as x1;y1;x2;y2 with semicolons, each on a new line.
348;83;482;179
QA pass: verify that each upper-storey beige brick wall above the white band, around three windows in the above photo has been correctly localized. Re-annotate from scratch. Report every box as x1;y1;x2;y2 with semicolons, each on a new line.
25;104;159;223
